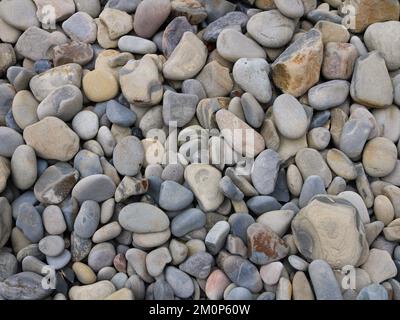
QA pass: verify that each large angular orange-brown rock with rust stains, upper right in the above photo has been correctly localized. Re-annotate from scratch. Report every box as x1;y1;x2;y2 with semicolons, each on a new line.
272;29;323;97
